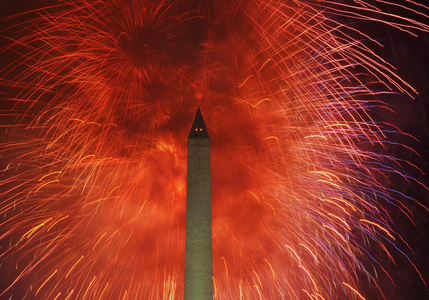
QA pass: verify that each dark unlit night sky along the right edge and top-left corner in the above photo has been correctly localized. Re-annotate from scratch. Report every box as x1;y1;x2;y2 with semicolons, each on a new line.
0;0;429;300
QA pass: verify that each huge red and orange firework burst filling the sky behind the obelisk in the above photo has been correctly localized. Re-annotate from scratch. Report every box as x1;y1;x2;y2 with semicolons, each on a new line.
0;0;429;299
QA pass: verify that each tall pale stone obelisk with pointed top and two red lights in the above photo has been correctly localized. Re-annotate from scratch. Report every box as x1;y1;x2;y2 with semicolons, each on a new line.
185;109;213;300
